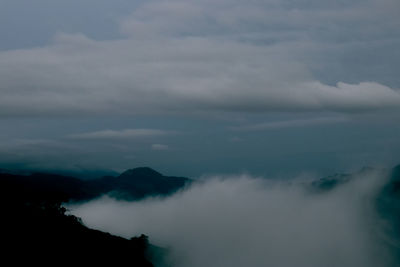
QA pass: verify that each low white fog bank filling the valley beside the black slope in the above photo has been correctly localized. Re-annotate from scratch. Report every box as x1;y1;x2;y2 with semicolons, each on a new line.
69;173;391;267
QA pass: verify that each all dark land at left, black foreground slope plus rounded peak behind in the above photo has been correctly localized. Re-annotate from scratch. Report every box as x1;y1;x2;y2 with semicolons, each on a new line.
0;168;189;266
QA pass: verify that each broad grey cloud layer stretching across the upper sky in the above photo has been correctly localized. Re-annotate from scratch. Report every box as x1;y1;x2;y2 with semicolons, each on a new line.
0;0;400;116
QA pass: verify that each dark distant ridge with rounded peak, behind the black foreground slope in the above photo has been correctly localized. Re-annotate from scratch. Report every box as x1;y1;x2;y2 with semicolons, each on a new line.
0;167;191;202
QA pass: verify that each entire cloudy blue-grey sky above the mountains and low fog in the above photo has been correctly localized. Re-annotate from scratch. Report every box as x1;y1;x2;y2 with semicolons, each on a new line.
0;0;400;177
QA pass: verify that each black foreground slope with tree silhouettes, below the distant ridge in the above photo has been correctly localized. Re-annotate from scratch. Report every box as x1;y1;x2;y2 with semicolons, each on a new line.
0;202;152;267
